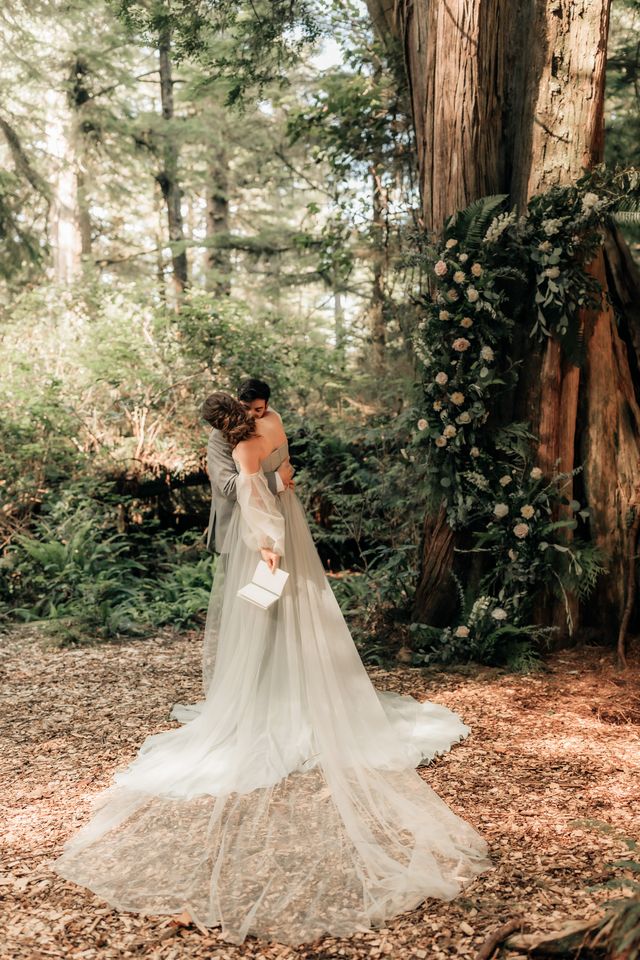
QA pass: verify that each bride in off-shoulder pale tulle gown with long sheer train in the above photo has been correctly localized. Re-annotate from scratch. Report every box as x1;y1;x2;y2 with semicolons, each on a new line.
53;393;489;945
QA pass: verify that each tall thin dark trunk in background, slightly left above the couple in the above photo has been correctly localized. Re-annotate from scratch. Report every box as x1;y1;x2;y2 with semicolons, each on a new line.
156;25;188;302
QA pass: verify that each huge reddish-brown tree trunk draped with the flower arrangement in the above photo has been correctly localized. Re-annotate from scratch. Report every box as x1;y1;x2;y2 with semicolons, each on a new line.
369;0;640;635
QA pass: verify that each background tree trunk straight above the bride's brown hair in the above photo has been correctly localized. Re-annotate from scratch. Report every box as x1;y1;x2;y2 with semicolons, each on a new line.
206;146;231;297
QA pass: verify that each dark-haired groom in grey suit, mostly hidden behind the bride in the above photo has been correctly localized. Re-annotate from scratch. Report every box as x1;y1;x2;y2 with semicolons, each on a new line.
203;379;293;553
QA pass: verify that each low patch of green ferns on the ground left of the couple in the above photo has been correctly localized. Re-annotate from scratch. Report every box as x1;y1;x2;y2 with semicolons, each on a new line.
0;487;213;643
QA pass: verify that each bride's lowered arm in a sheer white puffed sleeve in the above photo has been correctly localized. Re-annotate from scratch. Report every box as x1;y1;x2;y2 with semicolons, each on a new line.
234;440;284;559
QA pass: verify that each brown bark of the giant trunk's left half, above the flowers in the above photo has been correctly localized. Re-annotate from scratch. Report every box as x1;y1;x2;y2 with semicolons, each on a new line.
370;0;518;229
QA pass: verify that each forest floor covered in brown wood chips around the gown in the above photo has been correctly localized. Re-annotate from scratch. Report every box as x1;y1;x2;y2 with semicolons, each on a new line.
0;630;640;960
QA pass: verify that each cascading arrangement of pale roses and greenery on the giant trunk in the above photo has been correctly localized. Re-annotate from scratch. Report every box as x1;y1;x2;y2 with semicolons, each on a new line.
414;168;637;660
